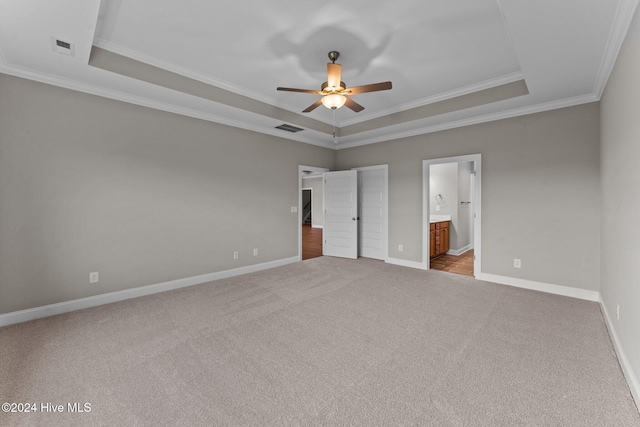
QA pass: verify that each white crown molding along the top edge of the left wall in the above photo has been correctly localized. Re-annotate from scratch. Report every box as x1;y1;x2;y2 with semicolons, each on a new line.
0;64;335;149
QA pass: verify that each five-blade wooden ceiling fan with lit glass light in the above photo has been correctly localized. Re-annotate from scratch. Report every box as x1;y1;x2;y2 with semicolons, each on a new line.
278;50;391;113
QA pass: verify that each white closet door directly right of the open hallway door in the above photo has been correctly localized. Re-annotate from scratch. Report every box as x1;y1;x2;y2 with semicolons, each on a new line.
358;166;387;260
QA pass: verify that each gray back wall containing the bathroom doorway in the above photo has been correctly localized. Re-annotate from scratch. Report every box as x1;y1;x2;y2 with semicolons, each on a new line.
337;103;600;291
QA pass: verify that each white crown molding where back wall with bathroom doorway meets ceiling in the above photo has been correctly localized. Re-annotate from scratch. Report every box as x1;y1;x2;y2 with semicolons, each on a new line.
336;94;599;150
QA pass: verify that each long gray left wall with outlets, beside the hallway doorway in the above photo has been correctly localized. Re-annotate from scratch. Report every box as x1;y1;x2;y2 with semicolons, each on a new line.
0;74;335;313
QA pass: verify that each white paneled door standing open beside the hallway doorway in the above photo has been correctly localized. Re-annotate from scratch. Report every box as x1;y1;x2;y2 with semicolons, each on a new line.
322;170;358;259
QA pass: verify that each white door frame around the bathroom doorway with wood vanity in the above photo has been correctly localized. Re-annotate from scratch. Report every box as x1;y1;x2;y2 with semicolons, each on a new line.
422;154;482;277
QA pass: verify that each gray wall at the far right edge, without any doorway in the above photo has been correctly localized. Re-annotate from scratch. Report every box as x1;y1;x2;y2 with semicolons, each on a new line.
601;38;640;396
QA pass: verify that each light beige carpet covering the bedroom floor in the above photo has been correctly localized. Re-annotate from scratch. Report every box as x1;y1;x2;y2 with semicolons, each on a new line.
0;257;640;426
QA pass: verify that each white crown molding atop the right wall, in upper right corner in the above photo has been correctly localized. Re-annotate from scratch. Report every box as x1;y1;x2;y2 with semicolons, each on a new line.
593;0;638;100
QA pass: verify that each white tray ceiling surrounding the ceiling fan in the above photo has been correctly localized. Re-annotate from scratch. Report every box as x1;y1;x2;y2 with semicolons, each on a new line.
0;0;638;148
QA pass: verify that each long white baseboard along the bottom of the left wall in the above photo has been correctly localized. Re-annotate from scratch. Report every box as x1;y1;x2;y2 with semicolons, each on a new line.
0;257;299;327
